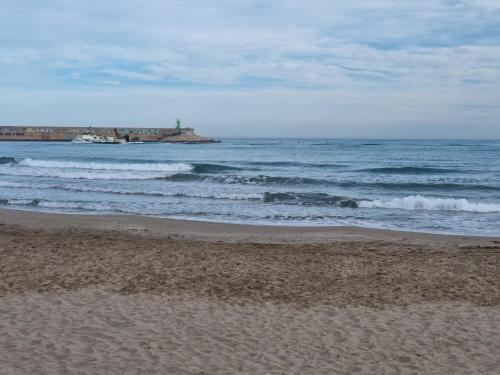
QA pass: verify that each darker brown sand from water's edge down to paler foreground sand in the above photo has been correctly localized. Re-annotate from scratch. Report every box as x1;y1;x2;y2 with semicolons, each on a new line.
0;210;500;307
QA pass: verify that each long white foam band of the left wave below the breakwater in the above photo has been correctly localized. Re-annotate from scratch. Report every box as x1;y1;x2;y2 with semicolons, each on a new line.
19;159;189;172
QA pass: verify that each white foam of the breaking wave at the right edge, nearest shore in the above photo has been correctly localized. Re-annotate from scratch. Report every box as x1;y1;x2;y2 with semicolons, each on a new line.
358;195;500;212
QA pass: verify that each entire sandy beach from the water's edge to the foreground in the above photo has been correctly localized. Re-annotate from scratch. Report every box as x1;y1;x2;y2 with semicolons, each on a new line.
0;210;500;374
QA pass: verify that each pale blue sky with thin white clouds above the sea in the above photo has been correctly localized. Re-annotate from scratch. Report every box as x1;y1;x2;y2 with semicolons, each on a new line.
0;0;500;139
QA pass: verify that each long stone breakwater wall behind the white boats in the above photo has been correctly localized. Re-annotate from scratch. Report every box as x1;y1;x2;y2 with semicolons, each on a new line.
0;126;211;142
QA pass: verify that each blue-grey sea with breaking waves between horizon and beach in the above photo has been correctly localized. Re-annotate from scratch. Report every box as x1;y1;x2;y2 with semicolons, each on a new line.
0;139;500;235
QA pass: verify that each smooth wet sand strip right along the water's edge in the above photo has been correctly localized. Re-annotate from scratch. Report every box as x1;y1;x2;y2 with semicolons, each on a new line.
0;208;500;244
